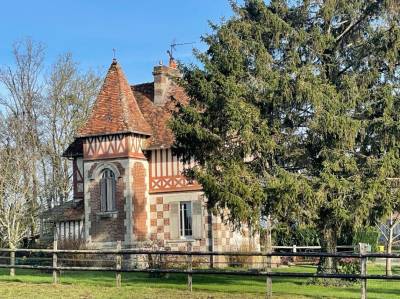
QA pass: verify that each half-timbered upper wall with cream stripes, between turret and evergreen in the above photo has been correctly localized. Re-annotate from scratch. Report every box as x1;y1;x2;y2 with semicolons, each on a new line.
149;149;201;193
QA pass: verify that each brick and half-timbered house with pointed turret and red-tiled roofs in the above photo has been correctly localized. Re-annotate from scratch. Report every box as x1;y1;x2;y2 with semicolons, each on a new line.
41;60;259;251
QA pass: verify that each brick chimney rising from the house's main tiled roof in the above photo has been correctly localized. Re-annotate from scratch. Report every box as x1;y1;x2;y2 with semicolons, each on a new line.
153;59;179;106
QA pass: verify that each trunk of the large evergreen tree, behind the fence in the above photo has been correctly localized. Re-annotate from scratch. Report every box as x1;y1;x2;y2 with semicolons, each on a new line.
317;227;337;273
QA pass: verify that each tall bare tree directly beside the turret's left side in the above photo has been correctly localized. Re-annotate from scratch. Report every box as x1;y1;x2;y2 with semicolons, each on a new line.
41;53;101;207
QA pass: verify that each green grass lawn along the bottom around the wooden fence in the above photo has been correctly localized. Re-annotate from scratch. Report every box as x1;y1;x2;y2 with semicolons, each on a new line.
0;265;400;299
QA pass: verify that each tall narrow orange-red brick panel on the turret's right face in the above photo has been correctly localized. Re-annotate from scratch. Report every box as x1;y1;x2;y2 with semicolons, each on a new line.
132;162;147;240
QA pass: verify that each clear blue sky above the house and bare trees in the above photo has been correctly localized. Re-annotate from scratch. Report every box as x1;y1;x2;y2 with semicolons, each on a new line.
0;0;232;83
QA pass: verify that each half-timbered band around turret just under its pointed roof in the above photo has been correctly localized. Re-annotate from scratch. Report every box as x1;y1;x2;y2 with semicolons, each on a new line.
83;134;146;160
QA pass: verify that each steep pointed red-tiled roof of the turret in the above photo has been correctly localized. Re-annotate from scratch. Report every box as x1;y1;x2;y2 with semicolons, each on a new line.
77;60;152;137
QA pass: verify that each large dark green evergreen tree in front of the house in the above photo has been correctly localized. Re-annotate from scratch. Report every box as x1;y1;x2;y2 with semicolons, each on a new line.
171;0;400;271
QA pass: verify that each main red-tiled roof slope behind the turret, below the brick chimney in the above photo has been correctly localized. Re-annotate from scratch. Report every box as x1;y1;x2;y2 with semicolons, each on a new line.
132;83;188;149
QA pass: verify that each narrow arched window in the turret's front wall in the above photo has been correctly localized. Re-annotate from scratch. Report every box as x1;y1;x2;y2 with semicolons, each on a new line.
100;168;116;212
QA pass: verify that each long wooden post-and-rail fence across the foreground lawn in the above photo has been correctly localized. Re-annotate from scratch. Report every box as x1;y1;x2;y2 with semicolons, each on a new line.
0;242;400;299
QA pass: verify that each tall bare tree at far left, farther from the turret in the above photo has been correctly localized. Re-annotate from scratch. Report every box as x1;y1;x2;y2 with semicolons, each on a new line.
0;39;44;240
